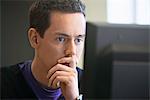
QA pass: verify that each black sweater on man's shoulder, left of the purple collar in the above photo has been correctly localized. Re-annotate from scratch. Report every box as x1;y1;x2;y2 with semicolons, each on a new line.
0;63;33;98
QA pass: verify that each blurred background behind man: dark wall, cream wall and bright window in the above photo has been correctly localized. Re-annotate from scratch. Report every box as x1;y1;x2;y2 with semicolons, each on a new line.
0;0;150;68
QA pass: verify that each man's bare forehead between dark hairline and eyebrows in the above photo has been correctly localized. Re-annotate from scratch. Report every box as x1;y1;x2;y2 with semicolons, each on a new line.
43;11;86;37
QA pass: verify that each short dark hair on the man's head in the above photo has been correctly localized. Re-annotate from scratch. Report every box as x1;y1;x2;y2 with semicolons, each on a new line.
29;0;85;37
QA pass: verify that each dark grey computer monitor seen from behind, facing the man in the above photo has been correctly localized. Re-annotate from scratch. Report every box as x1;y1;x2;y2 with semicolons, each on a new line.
81;22;150;100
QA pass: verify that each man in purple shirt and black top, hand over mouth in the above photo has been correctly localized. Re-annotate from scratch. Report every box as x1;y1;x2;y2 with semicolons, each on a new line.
1;0;86;100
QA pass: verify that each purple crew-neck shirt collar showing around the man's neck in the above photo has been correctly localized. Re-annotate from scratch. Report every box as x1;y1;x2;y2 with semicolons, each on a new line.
19;61;62;100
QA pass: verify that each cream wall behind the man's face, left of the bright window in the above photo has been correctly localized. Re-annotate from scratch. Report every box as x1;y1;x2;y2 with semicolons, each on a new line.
78;0;107;68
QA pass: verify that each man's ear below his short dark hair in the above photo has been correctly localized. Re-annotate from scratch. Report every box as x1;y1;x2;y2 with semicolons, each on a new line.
28;28;40;48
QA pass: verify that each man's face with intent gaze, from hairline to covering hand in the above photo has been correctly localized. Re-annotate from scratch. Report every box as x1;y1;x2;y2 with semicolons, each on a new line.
36;12;86;71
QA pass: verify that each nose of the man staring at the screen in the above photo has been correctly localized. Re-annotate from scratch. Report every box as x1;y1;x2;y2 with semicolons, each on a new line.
65;41;76;57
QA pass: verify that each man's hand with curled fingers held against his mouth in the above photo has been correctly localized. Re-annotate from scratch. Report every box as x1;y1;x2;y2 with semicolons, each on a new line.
47;57;79;100
